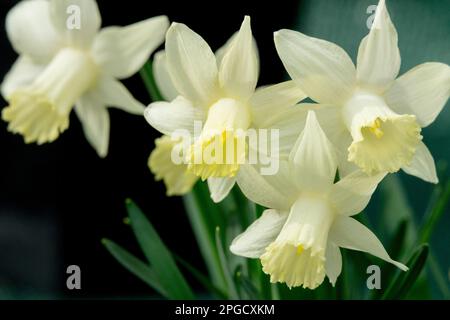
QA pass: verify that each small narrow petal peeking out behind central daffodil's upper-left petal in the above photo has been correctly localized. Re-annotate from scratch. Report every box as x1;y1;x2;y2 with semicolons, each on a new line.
153;50;178;101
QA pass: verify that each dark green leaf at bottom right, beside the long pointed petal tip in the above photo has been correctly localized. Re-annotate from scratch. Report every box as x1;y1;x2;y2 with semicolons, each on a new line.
382;244;428;300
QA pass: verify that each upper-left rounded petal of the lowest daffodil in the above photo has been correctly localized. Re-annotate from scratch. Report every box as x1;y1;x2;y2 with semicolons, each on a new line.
237;161;297;211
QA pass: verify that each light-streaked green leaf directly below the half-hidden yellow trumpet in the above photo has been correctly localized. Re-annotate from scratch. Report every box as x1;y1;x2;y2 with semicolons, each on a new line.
183;181;226;290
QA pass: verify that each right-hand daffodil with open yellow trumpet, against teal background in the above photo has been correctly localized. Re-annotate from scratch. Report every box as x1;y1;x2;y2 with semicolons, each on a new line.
275;0;450;183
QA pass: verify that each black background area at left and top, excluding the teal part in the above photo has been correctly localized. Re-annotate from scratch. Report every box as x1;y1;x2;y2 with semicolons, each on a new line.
0;0;299;298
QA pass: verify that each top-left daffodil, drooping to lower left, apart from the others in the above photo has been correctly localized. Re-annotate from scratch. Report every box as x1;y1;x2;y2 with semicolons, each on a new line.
1;0;169;157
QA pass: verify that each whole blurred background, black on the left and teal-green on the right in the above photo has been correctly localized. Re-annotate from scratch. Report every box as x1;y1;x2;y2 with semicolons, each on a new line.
0;0;450;299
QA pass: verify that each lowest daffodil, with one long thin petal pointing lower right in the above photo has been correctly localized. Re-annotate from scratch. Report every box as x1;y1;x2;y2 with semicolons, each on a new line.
230;111;407;289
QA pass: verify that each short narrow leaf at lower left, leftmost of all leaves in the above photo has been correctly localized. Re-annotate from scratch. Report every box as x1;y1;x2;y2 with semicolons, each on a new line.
102;239;169;298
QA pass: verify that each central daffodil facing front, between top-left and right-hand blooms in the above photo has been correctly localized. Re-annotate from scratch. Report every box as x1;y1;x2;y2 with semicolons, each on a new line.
145;17;306;202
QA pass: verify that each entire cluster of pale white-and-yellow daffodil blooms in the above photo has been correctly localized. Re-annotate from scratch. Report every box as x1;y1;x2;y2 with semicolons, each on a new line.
2;0;450;289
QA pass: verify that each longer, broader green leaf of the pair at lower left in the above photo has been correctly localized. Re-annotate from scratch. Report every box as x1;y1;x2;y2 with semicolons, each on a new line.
126;199;194;299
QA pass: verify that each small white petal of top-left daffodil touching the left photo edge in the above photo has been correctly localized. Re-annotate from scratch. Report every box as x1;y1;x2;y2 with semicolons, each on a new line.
1;56;45;99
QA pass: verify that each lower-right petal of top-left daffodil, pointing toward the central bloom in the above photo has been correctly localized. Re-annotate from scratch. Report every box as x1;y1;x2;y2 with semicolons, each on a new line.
94;77;145;115
